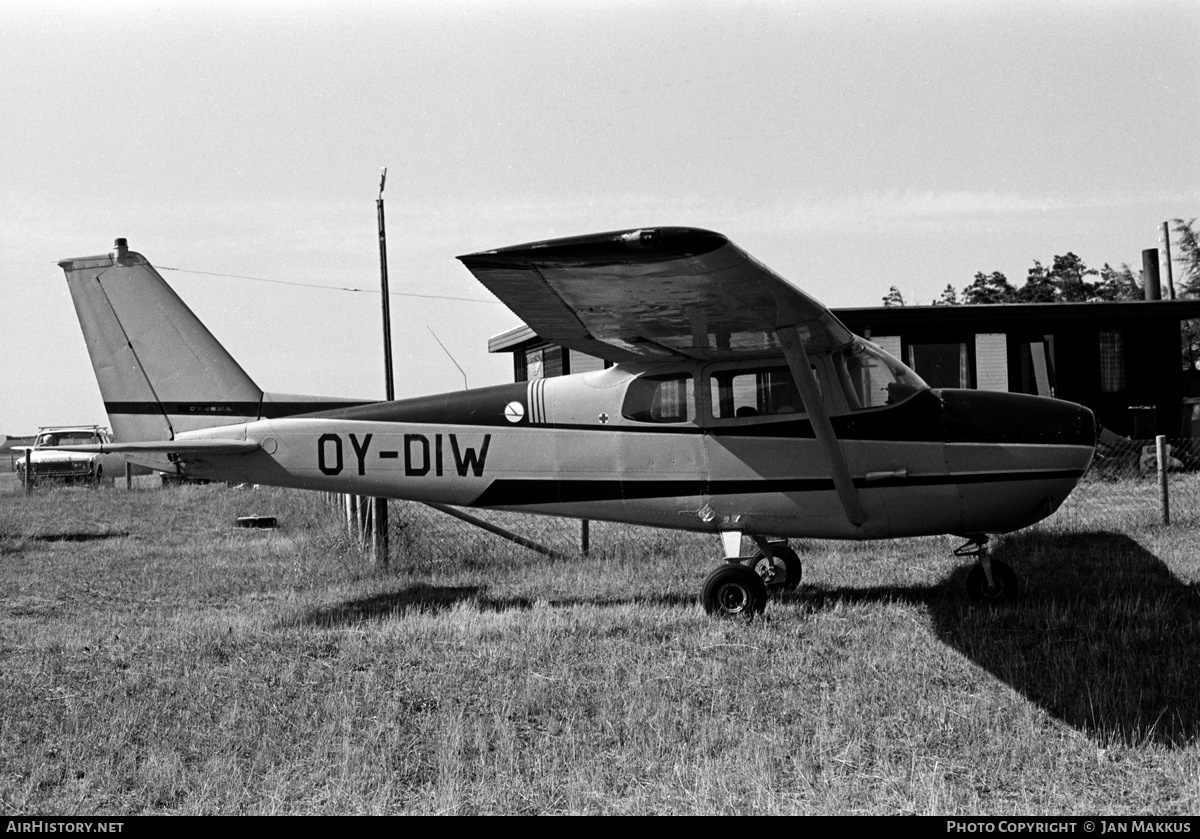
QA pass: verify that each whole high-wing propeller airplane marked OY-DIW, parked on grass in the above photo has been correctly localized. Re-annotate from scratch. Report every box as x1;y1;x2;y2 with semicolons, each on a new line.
60;228;1096;617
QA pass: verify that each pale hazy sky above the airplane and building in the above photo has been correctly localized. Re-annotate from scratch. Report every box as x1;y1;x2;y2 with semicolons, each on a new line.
0;0;1200;435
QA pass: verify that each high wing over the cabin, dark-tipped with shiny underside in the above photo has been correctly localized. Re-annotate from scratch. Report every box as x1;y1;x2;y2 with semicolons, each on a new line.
458;227;853;362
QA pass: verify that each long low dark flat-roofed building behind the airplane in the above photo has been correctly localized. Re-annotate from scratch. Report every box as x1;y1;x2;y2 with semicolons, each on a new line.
487;300;1200;439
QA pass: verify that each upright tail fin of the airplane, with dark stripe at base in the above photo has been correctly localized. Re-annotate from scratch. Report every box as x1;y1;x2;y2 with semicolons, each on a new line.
59;239;263;443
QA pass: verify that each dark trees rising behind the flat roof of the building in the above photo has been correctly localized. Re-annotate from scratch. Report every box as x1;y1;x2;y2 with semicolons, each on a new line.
883;218;1200;306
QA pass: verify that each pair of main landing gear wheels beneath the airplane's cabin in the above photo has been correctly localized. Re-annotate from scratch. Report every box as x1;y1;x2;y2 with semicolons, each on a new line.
700;533;804;623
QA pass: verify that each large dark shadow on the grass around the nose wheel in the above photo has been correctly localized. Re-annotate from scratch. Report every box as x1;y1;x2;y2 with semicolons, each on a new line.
788;532;1200;745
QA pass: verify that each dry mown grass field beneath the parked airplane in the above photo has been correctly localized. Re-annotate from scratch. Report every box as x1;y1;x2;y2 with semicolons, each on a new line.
0;483;1200;814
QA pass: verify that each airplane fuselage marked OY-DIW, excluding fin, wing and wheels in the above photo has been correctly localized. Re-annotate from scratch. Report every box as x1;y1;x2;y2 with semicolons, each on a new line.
166;364;1094;539
